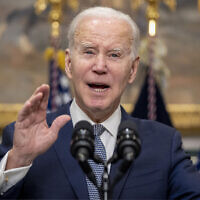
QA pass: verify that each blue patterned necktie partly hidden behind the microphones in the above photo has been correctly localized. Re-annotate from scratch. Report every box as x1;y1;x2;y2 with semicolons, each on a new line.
86;124;106;200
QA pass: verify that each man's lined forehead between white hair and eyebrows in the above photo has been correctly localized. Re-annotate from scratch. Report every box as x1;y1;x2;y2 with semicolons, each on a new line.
74;16;132;46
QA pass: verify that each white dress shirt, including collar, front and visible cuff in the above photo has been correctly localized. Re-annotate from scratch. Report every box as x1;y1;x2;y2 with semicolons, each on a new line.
0;99;121;194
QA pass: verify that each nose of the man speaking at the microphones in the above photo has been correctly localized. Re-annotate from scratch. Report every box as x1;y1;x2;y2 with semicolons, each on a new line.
92;54;107;74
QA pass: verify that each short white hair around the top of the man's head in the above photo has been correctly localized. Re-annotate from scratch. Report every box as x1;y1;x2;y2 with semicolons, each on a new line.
68;7;140;58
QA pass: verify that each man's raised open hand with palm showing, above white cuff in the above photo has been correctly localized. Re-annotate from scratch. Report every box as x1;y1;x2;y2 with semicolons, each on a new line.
6;85;70;170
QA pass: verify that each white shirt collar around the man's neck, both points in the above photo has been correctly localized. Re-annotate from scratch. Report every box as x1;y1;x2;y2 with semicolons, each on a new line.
70;99;121;137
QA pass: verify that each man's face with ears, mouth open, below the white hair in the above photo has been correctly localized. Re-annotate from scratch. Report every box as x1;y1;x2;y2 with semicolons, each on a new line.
66;17;139;122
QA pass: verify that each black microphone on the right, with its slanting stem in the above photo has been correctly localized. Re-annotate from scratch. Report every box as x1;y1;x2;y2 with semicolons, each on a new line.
109;120;141;198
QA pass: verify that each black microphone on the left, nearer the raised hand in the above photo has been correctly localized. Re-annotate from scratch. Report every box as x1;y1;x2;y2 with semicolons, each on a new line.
71;120;97;185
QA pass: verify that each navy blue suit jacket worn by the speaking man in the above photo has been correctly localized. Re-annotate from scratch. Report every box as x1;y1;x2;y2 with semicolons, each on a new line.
0;105;200;199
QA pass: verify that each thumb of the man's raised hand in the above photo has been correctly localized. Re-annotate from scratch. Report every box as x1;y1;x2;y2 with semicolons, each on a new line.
50;115;71;134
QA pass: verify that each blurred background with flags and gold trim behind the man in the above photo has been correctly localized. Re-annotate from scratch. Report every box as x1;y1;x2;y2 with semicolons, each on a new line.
0;0;200;164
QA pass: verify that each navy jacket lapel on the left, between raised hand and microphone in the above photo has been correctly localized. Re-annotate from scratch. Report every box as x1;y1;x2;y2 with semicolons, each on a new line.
48;102;89;199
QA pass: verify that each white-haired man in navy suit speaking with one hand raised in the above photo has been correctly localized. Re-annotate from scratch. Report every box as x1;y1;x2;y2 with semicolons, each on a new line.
0;7;200;199
